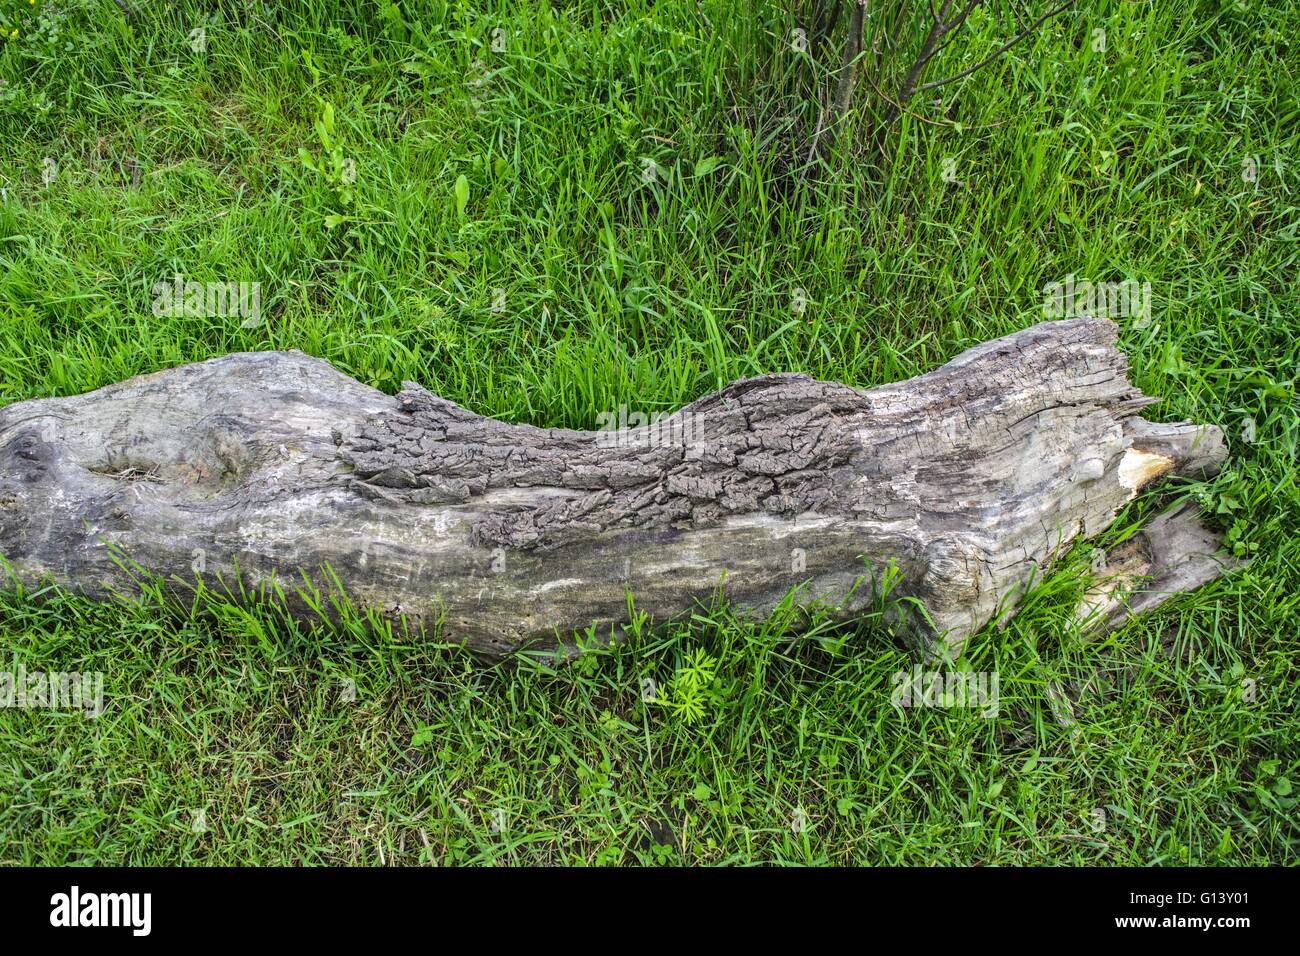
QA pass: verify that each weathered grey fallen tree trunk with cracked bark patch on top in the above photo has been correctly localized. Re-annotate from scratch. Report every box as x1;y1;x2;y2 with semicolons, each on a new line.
0;319;1225;656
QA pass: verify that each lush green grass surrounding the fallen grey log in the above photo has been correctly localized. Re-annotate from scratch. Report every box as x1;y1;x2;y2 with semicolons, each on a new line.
0;0;1300;865
